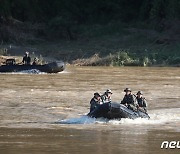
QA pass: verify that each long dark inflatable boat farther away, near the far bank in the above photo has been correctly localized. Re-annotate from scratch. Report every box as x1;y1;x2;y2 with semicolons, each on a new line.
0;59;65;73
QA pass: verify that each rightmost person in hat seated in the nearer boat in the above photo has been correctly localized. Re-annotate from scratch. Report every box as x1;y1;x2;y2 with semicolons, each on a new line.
136;91;147;113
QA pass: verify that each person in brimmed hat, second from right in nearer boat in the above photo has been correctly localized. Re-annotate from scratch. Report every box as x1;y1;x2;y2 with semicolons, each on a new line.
121;88;138;111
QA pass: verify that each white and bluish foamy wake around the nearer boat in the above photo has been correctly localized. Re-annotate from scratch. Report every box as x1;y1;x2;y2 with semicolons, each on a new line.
58;108;180;125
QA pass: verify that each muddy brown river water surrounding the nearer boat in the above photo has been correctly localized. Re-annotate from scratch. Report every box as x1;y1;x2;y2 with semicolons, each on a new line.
0;67;180;154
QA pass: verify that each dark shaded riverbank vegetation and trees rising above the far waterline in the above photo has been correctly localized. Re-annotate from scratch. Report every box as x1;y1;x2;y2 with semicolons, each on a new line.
0;0;180;66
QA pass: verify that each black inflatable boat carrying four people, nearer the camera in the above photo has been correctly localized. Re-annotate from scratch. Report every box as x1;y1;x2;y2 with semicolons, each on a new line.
88;102;150;119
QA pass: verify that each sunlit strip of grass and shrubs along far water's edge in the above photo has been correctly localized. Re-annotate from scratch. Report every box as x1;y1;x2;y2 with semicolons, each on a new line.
72;51;180;66
